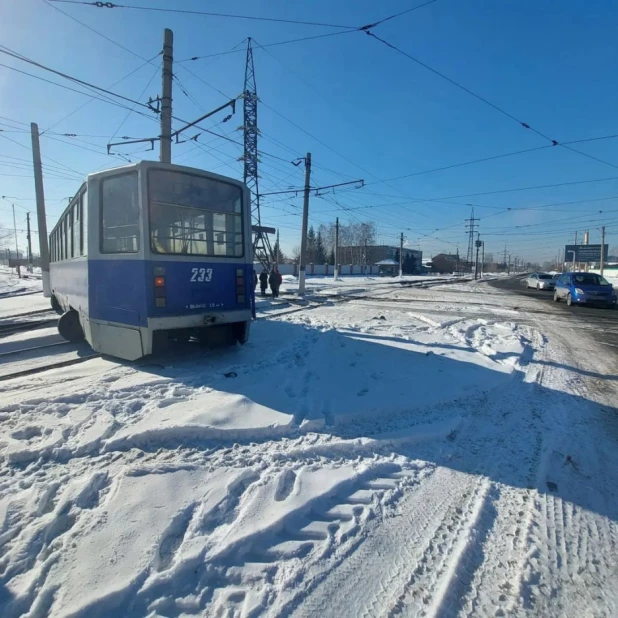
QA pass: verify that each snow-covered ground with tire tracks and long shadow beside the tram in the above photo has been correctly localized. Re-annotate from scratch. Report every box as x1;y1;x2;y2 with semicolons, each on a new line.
0;280;618;618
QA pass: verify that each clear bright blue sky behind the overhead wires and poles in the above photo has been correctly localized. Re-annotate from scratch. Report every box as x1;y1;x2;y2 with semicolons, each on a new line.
0;0;618;261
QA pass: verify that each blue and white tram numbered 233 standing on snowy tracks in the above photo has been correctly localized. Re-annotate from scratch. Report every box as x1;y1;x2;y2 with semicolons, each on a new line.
50;161;254;360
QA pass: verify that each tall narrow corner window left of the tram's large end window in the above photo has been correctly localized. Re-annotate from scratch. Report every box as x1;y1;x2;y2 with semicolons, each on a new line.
101;173;139;253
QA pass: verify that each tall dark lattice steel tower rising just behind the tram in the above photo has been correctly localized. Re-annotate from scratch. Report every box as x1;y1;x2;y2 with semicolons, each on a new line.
242;38;275;270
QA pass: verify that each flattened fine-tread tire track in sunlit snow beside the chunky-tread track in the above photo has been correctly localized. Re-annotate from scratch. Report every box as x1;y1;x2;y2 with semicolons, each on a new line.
281;468;478;618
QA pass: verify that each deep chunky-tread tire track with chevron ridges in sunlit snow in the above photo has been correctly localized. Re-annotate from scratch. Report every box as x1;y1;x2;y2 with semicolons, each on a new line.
202;464;415;616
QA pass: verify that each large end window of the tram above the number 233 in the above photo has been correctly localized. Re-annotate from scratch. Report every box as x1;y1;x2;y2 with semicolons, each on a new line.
148;169;243;257
